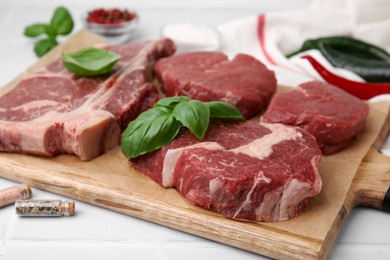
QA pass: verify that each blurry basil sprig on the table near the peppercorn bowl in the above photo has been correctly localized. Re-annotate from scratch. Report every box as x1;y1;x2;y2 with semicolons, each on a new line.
24;6;74;57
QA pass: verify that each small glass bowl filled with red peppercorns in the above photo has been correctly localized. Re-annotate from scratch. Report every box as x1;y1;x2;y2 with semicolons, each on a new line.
82;8;139;44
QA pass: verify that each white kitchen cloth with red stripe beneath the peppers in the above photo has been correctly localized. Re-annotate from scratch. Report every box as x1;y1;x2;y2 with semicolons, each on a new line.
218;0;390;155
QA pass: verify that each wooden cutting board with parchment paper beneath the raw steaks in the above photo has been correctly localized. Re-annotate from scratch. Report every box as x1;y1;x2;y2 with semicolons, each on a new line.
0;30;390;259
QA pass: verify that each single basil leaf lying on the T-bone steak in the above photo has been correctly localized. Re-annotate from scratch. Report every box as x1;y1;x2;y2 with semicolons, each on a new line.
62;48;121;76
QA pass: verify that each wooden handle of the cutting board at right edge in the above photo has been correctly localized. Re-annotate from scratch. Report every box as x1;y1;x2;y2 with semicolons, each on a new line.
351;148;390;212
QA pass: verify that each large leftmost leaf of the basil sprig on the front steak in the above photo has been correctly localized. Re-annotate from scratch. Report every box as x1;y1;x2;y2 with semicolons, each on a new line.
121;107;180;158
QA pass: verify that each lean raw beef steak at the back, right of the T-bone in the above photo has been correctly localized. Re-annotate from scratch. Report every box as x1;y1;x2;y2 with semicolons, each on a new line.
154;52;276;118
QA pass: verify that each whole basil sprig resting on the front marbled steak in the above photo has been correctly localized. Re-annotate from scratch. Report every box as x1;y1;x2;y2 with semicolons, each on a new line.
121;96;244;158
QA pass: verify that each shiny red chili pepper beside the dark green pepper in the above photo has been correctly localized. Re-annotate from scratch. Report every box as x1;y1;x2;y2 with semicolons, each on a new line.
302;55;390;99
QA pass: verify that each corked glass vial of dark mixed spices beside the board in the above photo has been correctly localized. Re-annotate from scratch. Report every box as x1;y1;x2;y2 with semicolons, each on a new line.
15;200;75;217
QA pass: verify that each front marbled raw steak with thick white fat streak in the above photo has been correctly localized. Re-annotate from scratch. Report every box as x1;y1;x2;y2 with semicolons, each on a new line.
130;121;322;221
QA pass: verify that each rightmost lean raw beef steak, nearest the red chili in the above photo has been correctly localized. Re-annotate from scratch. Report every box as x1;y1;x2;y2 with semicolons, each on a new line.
261;81;369;155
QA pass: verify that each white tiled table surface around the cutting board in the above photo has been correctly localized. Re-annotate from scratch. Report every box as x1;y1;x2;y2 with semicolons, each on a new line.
0;0;390;260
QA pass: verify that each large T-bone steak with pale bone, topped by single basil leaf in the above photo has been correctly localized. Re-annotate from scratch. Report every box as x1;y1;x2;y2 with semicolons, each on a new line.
0;40;175;160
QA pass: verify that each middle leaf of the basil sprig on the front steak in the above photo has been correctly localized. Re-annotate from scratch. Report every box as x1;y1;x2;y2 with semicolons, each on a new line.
173;100;210;140
